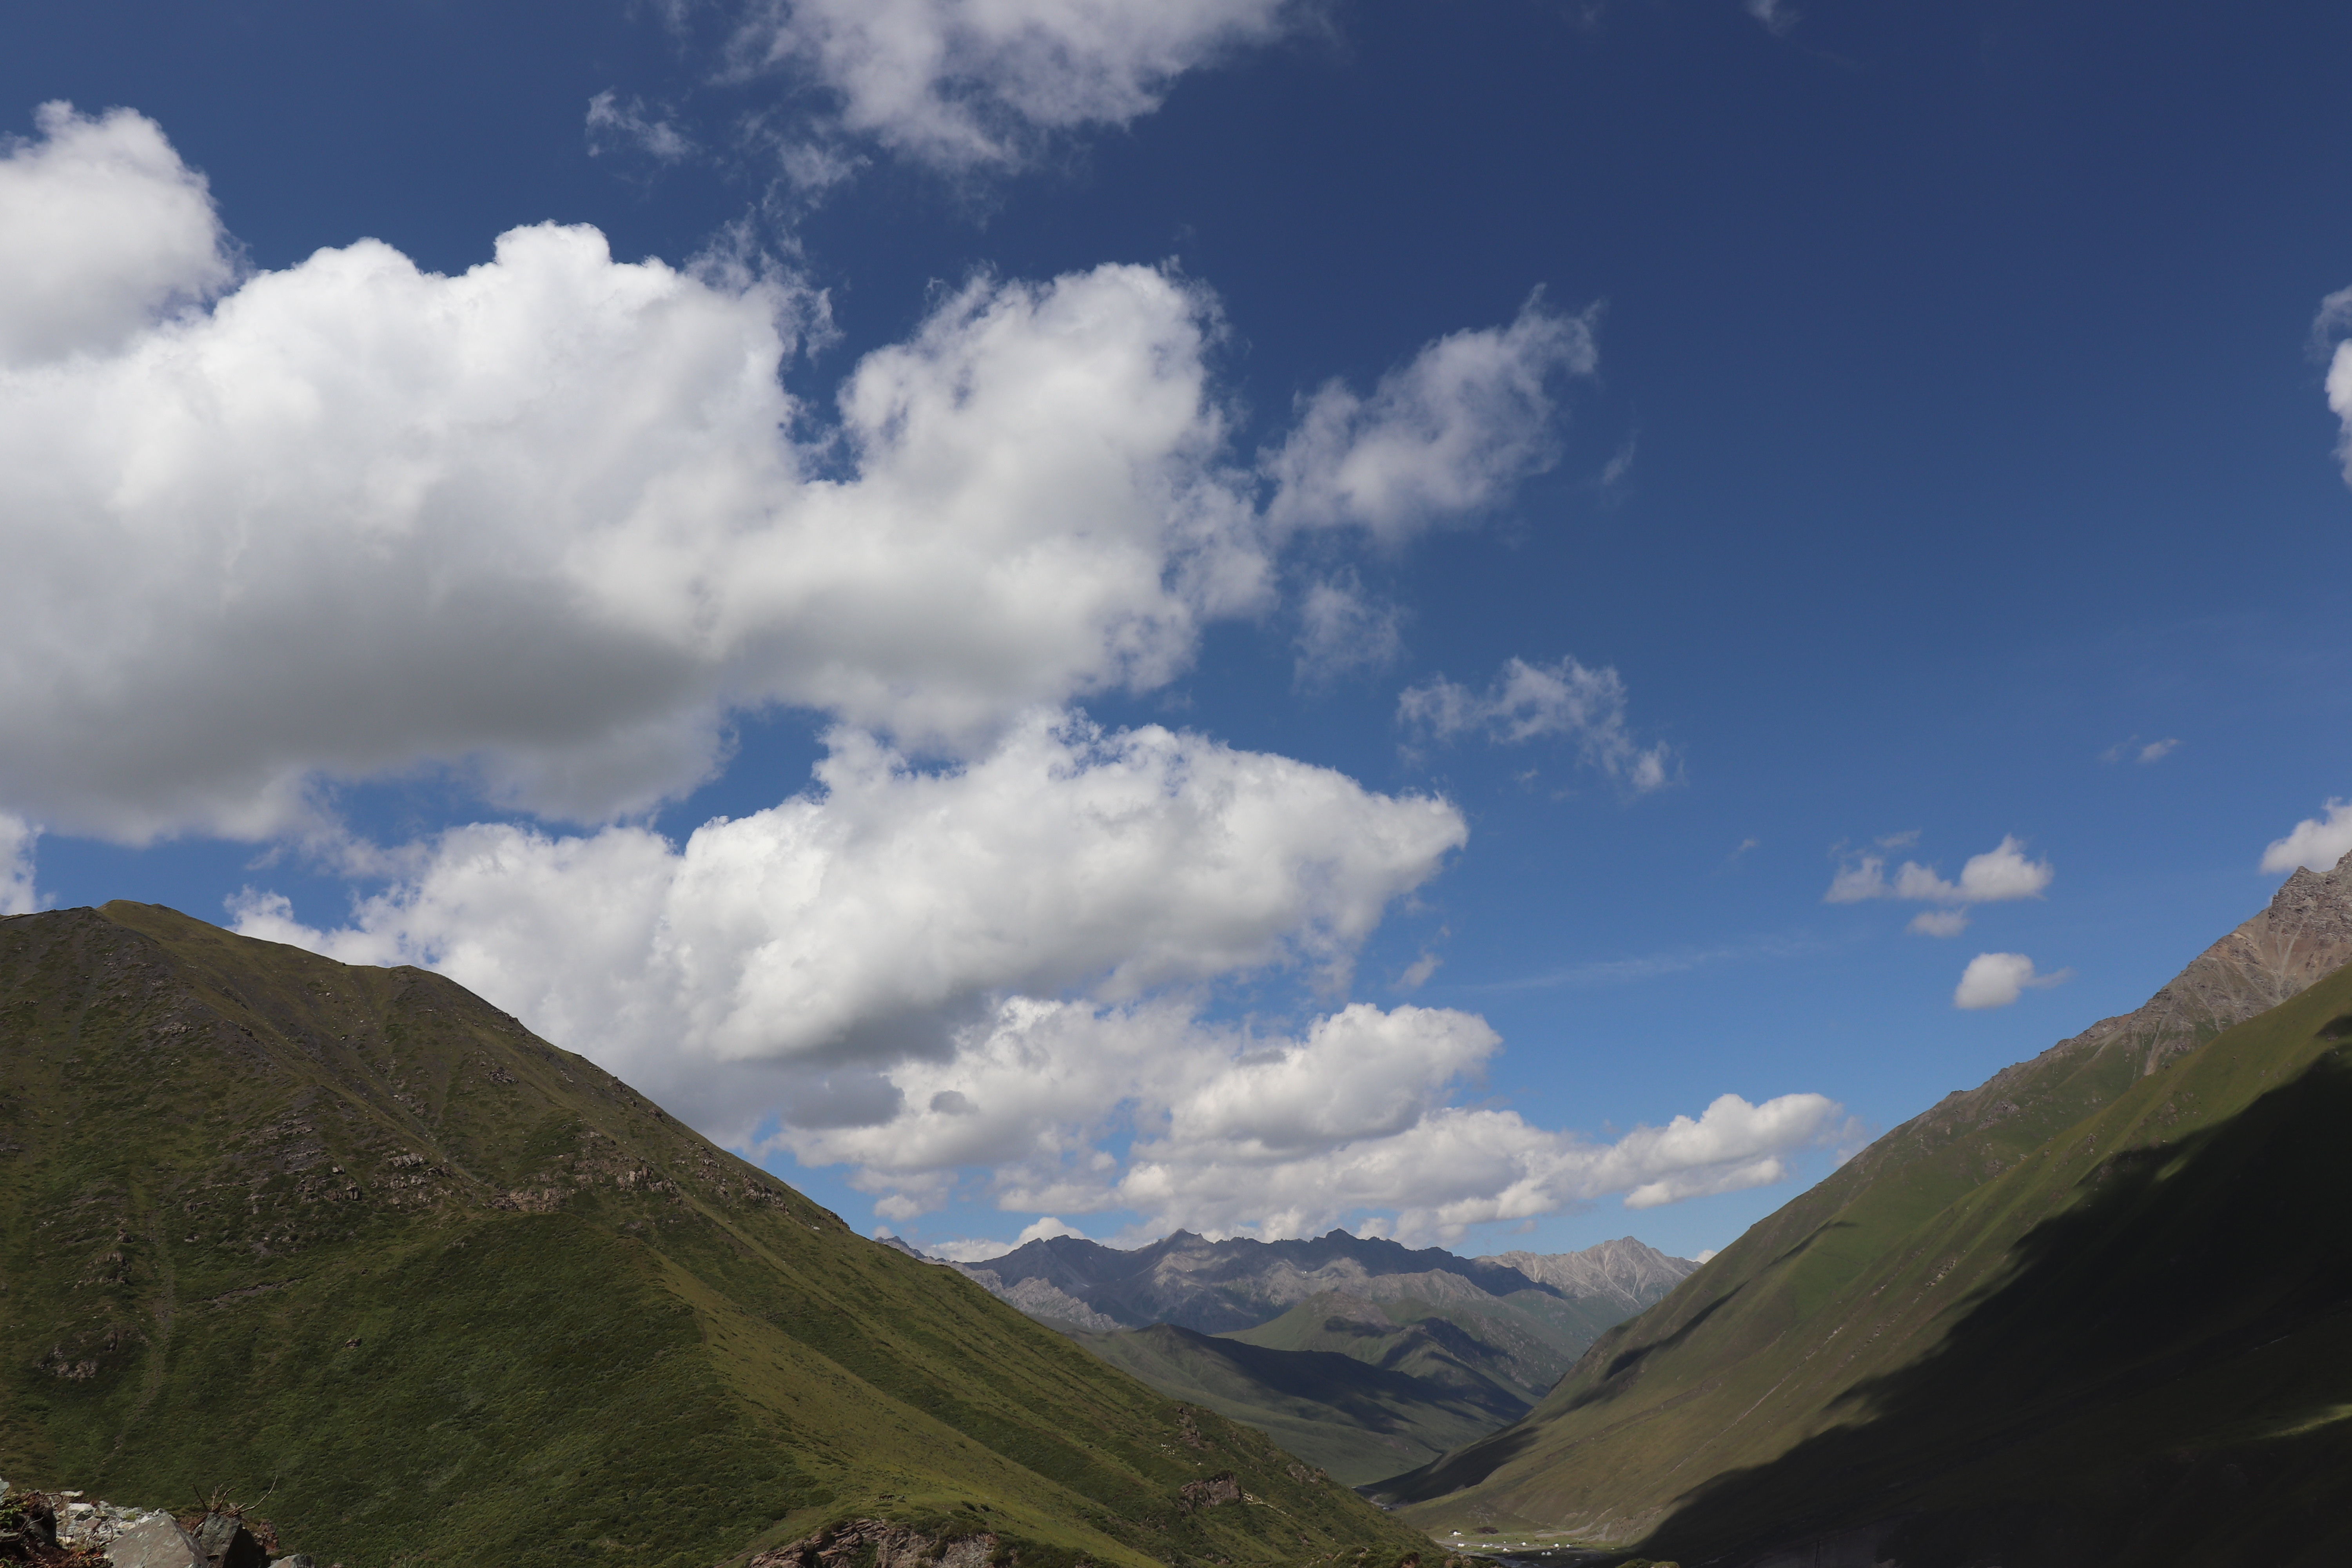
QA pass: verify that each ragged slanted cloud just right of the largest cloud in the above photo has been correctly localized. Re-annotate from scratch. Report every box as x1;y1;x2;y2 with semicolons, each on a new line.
1265;299;1599;545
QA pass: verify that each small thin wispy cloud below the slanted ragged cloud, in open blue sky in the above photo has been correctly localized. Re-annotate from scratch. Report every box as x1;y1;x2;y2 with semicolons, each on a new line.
1397;658;1675;792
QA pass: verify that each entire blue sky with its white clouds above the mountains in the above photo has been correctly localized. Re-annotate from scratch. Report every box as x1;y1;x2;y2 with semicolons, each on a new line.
0;0;2352;1253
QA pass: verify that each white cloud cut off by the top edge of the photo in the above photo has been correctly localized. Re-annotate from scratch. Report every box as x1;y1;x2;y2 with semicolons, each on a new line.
736;0;1301;169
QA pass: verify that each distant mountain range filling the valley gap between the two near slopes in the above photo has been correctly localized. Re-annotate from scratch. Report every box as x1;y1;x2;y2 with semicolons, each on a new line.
936;1229;1698;1486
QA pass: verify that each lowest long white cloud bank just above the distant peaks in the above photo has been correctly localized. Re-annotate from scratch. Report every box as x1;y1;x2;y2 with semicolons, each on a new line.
779;999;1837;1241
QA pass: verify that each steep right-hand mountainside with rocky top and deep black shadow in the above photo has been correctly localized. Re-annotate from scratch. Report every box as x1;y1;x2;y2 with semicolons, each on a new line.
1390;863;2352;1568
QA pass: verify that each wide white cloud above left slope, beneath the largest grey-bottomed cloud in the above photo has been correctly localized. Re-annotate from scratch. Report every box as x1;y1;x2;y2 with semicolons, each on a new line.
225;715;1465;1140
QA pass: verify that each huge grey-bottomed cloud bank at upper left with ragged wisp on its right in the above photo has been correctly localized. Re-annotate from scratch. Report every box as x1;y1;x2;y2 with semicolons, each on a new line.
0;108;1618;842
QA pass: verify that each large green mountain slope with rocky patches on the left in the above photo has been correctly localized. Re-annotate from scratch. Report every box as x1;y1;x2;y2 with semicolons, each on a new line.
0;905;1425;1568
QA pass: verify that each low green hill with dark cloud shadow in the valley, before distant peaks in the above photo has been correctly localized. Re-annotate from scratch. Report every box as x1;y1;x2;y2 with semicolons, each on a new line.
1073;1323;1526;1486
